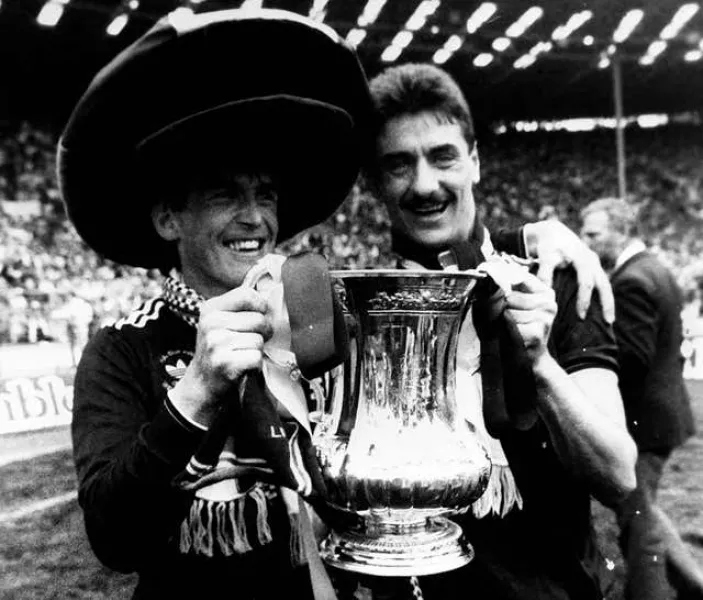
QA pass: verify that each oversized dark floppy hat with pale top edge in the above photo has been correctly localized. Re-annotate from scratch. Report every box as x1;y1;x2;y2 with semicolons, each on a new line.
58;10;373;267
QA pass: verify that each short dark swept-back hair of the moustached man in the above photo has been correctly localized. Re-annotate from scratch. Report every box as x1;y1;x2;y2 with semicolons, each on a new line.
369;63;475;149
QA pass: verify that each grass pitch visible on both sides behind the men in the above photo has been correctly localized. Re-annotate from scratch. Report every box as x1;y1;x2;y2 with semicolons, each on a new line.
0;381;703;600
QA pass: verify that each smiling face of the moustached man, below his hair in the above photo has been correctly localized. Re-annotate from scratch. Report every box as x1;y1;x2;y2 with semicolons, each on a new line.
376;112;480;249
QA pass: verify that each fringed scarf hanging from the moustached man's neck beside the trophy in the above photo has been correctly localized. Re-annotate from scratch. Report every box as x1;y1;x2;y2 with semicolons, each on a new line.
393;219;536;518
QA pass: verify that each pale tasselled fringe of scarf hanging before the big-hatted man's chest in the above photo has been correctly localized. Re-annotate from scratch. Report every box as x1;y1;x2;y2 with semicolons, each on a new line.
179;487;272;557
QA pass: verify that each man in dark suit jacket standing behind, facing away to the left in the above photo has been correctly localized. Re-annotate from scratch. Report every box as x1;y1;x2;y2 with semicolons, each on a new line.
581;198;703;600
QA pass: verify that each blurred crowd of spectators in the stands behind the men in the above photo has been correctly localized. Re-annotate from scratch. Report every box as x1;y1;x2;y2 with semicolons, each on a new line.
0;123;703;343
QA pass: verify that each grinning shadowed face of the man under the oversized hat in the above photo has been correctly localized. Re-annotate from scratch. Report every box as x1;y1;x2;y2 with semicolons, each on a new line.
157;173;278;298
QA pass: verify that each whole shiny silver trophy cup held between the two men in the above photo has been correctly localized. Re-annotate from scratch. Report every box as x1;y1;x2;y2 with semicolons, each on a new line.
313;270;491;576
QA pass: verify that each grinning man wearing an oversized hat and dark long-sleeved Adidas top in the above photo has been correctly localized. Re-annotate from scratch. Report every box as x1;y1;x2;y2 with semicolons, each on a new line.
58;10;372;600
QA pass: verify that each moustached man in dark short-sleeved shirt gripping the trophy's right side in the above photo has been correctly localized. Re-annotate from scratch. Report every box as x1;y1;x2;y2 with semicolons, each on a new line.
354;64;636;600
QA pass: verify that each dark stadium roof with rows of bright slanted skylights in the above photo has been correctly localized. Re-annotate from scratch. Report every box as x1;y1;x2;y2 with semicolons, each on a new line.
0;0;703;131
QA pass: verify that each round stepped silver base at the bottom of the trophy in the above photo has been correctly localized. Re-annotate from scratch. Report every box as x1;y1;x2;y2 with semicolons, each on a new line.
320;517;474;577
